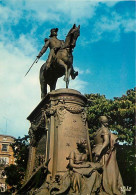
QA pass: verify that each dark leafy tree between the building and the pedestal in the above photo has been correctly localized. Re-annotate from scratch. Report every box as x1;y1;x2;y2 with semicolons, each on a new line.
5;135;29;190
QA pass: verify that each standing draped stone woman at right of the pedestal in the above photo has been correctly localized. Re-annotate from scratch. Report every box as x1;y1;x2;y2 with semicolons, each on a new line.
92;116;123;195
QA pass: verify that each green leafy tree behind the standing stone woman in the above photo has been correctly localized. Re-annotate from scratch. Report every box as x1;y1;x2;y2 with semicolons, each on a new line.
86;89;136;145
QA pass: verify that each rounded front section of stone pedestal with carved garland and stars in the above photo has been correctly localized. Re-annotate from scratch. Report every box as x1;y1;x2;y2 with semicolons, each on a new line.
46;89;89;176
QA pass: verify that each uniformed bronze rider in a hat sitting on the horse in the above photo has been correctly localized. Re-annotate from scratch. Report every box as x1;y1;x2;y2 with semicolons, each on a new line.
37;28;78;79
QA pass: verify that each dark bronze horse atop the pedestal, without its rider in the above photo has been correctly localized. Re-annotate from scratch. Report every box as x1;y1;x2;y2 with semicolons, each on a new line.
40;24;80;98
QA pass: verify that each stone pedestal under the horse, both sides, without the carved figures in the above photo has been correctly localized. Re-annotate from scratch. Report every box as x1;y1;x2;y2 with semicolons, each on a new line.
19;89;91;194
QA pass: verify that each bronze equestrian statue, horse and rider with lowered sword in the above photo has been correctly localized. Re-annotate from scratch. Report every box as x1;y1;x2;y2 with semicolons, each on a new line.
26;24;80;99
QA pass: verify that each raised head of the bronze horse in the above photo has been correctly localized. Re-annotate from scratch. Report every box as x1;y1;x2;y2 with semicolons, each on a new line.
67;24;80;49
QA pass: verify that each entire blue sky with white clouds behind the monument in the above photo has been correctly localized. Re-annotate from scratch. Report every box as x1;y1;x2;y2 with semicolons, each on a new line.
0;0;136;137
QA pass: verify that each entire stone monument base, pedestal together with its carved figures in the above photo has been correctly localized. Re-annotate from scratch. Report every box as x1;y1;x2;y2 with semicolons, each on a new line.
18;89;123;195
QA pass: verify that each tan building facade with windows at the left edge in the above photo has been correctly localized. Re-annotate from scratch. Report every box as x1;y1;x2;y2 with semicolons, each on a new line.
0;135;15;192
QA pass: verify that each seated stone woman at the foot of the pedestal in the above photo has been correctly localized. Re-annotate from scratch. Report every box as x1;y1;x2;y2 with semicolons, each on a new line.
68;140;101;194
